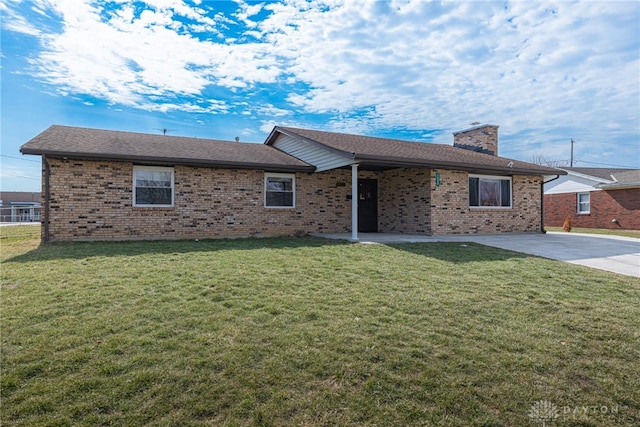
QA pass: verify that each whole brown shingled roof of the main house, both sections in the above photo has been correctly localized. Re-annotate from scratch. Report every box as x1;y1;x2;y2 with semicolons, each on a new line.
20;125;566;175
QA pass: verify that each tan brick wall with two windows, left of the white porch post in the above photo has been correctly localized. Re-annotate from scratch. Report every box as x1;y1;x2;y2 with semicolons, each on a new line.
43;159;351;241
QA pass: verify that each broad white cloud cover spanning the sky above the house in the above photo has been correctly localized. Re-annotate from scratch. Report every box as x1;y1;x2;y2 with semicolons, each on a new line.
3;0;640;166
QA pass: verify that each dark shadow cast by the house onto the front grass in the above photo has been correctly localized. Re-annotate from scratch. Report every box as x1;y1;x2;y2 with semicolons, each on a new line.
4;237;531;263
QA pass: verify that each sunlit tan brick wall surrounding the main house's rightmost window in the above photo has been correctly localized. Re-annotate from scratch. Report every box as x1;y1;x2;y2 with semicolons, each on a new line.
431;170;542;235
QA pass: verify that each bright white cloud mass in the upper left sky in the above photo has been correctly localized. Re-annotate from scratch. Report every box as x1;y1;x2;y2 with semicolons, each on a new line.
8;0;279;111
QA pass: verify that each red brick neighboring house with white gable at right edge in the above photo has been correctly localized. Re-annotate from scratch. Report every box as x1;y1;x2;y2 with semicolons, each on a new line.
544;168;640;230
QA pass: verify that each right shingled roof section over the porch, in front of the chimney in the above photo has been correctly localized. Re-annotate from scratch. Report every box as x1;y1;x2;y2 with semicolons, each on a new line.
265;126;566;175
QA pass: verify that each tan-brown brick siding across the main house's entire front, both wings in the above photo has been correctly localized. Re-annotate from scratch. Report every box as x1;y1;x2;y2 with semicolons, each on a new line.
43;158;542;241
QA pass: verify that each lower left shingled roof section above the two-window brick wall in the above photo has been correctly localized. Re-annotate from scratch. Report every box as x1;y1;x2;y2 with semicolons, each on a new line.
20;125;315;172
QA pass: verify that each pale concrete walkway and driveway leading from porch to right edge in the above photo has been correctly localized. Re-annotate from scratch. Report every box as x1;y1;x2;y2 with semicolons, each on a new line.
315;232;640;277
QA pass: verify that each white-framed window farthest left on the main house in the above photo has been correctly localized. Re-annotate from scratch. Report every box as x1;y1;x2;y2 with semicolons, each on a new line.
133;166;174;208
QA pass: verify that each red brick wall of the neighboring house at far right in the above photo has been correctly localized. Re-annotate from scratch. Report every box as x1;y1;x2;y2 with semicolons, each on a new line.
544;188;640;230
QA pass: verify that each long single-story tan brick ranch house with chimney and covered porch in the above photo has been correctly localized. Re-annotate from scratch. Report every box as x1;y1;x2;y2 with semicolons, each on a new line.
21;125;564;241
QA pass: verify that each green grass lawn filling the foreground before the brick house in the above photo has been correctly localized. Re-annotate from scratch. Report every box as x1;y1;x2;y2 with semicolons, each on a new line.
0;227;640;427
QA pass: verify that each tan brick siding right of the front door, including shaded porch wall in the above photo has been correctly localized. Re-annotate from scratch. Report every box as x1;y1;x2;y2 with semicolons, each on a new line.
359;169;542;235
